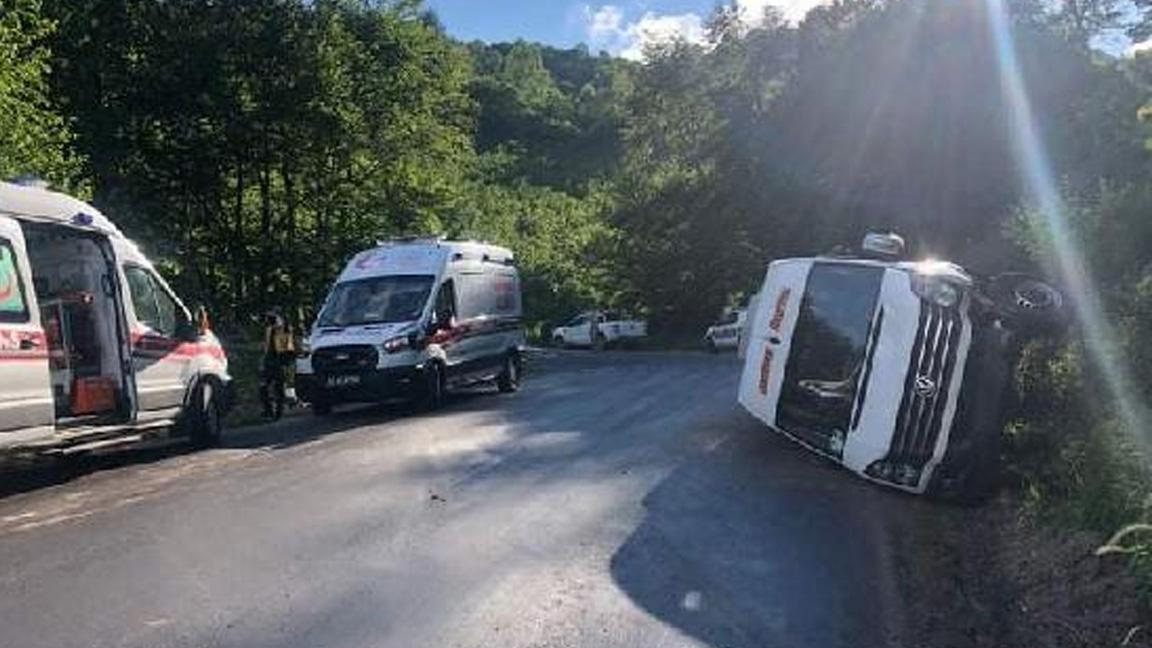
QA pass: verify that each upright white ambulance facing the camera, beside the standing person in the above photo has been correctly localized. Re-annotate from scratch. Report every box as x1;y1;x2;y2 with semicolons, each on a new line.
296;234;524;415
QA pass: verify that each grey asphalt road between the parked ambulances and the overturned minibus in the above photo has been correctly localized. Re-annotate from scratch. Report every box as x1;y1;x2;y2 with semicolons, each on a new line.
0;353;909;648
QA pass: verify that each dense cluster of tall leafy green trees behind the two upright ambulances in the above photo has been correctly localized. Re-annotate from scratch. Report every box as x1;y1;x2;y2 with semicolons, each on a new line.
52;0;471;322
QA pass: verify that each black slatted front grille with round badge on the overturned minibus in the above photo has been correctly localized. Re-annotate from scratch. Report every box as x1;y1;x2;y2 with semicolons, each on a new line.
867;302;963;487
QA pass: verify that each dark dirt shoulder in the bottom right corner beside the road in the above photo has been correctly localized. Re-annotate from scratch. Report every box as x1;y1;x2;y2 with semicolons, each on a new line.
895;496;1152;648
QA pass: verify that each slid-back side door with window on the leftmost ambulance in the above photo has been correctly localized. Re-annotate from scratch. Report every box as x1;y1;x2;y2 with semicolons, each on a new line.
0;216;55;433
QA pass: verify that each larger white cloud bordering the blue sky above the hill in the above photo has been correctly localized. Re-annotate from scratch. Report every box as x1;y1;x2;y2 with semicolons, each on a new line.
584;5;706;60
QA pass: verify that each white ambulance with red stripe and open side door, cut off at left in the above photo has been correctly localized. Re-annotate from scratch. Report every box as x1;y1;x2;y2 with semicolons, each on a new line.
0;182;232;451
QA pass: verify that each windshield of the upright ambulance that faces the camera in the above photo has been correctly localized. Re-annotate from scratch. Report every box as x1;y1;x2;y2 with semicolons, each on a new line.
318;274;434;326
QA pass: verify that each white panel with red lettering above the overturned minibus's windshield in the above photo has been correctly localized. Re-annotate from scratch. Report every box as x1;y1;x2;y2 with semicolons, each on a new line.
738;259;812;427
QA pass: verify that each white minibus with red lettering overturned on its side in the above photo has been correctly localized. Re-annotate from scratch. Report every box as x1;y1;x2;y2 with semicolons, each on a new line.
738;235;1067;499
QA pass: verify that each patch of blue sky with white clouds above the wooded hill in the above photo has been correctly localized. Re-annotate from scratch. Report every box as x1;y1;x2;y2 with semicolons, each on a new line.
426;0;819;58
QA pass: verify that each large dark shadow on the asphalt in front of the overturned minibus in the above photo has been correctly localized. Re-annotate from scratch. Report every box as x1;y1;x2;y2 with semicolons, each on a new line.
611;413;911;648
